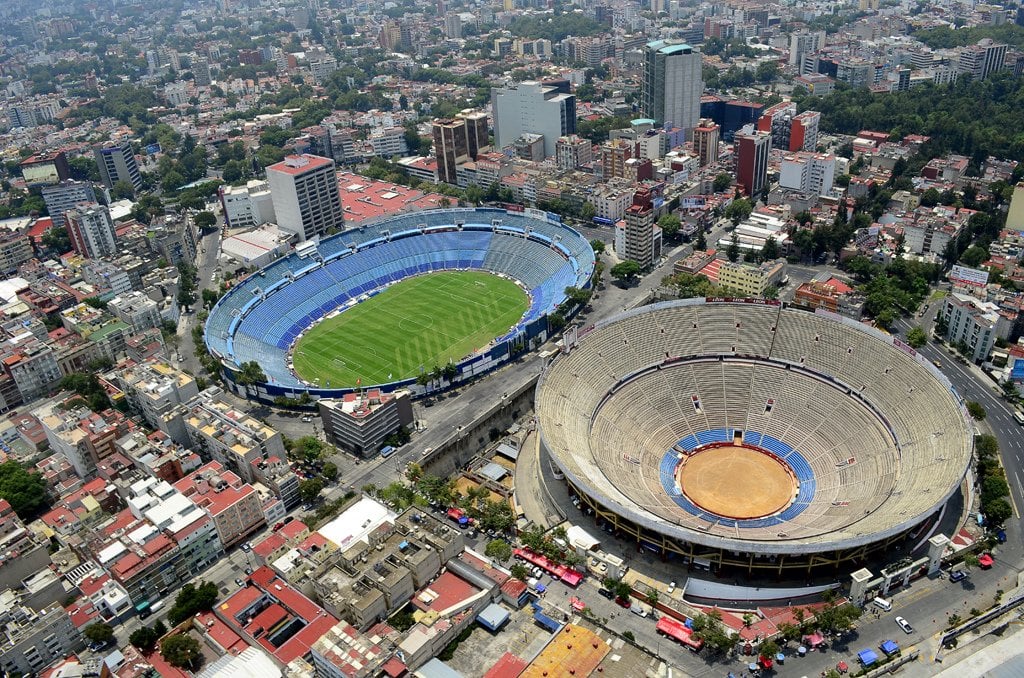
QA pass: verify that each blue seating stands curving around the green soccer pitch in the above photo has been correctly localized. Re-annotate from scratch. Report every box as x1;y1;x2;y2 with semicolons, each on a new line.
206;209;594;386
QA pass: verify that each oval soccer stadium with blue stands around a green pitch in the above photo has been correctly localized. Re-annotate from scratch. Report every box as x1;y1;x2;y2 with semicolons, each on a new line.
205;209;594;399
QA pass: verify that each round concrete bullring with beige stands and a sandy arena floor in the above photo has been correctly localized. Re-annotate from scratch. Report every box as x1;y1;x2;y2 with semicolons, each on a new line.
536;299;973;573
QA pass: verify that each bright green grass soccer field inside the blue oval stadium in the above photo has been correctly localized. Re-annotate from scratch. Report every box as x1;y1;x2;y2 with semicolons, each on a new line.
292;271;529;388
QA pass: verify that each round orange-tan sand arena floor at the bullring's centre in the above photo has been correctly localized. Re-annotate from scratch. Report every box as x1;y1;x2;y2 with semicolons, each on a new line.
676;443;800;520
